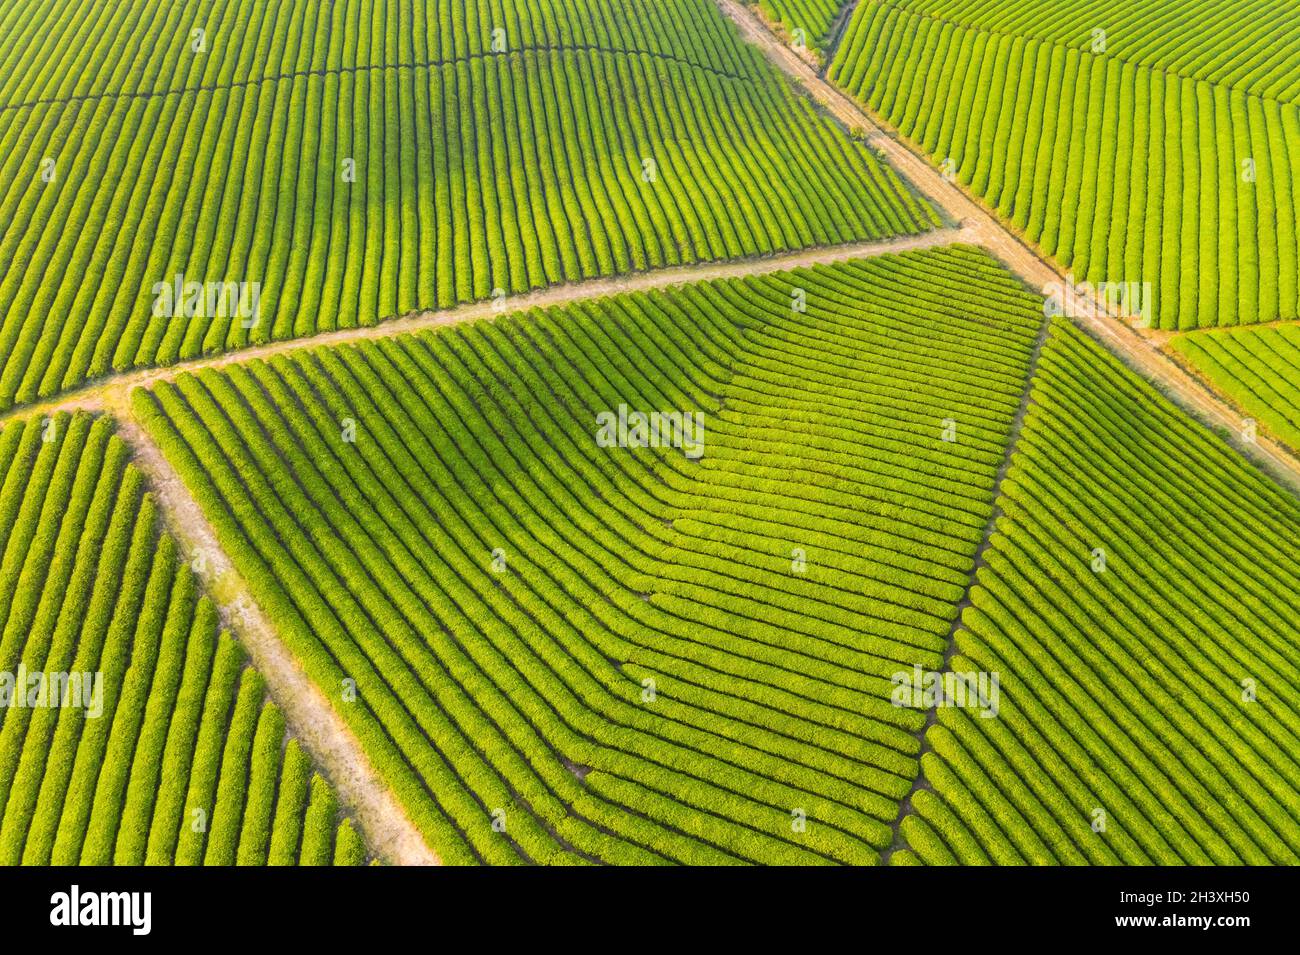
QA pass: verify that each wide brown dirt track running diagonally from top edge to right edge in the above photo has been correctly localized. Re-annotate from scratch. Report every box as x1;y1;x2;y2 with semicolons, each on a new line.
714;0;1300;492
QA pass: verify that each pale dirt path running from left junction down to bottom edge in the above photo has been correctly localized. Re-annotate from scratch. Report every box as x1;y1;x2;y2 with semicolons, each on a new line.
105;404;438;865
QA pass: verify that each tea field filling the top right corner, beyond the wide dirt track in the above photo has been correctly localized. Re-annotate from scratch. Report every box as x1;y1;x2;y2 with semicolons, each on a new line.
829;0;1300;329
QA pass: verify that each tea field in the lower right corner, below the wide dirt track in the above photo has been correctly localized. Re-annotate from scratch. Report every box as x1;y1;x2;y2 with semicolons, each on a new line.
904;322;1300;865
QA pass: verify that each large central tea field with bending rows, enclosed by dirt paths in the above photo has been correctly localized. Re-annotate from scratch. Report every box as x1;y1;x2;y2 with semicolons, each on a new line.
135;248;1041;863
